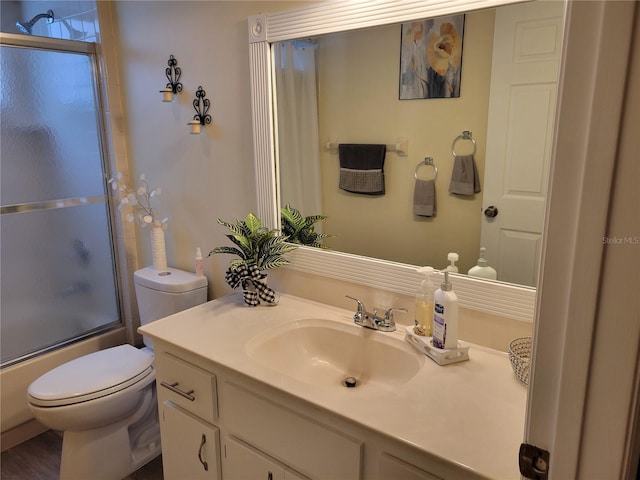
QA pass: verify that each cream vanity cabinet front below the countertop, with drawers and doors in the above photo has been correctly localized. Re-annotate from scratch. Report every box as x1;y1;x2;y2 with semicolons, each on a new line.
156;342;484;480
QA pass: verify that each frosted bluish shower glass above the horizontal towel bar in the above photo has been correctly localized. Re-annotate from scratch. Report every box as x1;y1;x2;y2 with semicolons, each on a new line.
0;46;104;205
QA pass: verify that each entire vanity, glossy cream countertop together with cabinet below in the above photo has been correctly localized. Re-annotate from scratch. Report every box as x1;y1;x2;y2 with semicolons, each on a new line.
140;294;526;480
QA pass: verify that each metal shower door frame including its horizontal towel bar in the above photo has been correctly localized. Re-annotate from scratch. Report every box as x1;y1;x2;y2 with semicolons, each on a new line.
0;32;127;369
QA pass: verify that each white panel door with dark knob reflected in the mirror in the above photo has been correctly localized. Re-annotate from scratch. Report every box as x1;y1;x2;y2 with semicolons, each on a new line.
481;2;564;286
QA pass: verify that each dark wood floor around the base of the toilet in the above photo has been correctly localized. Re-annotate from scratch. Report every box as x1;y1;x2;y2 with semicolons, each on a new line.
0;430;163;480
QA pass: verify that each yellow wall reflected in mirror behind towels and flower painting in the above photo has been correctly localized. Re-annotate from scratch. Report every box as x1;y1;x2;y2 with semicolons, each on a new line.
318;10;494;272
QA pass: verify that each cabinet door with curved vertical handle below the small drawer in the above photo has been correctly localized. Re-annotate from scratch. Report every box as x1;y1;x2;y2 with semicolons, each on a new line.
160;401;220;480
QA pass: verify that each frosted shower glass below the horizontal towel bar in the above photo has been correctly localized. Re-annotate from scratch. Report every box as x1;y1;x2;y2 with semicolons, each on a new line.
0;203;119;362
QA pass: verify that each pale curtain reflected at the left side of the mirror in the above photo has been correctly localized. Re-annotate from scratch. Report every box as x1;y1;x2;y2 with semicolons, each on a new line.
274;41;322;216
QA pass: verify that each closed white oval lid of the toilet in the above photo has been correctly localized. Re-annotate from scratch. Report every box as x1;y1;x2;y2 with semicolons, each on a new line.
28;345;154;407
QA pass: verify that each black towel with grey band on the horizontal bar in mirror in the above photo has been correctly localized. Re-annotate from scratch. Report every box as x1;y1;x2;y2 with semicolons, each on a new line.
338;143;387;195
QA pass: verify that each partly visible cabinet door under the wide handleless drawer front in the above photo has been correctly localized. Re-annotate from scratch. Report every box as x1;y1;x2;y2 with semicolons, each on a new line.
224;437;284;480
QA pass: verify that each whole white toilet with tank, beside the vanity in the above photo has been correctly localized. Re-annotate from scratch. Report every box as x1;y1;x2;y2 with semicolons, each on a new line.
28;267;207;480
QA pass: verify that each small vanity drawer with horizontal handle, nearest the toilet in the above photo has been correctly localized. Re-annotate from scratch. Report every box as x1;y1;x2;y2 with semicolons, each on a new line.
156;353;218;423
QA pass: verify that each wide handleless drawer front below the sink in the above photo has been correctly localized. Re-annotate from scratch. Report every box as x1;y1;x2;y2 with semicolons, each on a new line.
221;383;363;480
